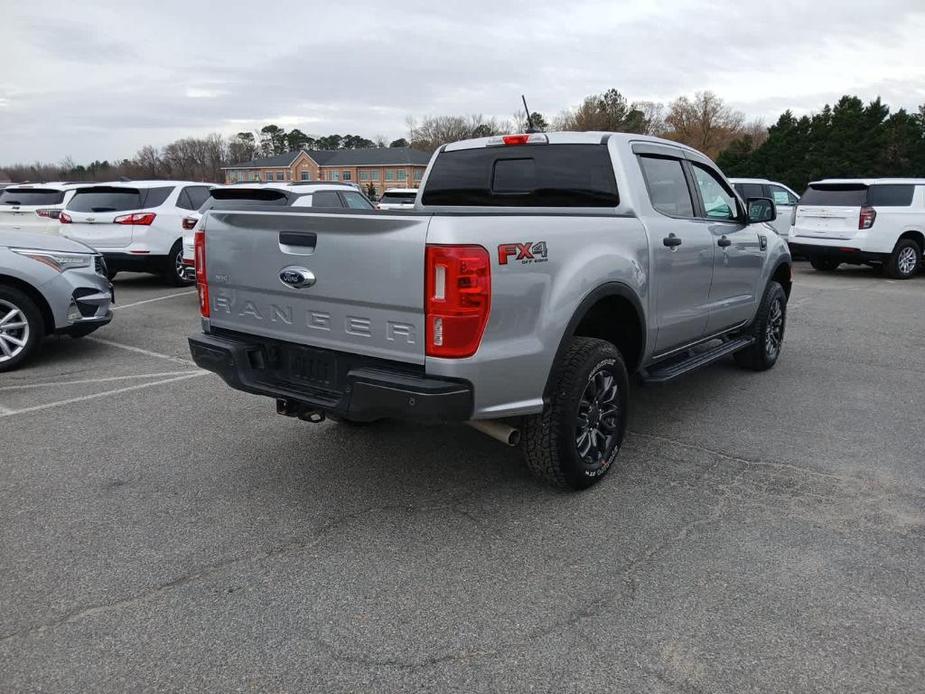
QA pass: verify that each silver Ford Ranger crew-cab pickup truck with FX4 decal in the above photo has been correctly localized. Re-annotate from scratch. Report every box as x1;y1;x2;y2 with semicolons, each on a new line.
189;133;791;489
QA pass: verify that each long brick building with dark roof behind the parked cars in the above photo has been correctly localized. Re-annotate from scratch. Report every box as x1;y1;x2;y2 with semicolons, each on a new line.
224;147;430;195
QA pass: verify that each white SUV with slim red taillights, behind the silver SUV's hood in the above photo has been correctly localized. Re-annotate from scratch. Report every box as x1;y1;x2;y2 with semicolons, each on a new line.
58;181;209;285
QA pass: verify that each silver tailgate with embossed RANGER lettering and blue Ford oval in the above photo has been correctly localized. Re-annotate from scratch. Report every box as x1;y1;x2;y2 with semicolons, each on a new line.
205;208;430;364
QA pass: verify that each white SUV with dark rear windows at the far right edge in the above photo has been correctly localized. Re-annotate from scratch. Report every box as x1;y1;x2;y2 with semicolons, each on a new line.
790;178;925;279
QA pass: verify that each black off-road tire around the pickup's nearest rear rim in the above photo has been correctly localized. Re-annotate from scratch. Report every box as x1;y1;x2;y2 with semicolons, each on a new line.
521;337;629;489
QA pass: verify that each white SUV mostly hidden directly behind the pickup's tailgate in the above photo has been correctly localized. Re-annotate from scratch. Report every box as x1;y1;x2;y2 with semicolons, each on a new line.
181;182;373;280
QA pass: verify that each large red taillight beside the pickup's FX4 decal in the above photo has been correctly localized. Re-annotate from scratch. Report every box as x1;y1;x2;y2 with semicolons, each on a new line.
422;245;491;359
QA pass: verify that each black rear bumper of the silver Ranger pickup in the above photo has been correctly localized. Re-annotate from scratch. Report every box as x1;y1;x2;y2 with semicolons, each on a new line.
189;334;473;421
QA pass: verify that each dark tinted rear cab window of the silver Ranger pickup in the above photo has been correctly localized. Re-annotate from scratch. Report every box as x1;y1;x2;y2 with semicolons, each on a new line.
422;144;620;207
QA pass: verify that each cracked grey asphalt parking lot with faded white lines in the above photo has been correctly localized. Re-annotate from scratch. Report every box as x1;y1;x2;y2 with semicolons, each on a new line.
0;264;925;692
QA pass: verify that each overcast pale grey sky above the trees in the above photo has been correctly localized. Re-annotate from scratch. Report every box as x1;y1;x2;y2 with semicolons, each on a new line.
0;0;925;164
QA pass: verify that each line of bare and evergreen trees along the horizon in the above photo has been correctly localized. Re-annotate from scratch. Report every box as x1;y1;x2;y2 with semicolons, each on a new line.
4;89;925;190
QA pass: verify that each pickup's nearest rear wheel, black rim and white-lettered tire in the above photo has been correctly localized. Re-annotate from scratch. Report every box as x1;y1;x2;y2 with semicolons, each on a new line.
521;337;629;489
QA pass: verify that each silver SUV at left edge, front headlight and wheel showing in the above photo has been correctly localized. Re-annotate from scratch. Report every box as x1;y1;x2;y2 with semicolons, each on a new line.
0;231;113;371
